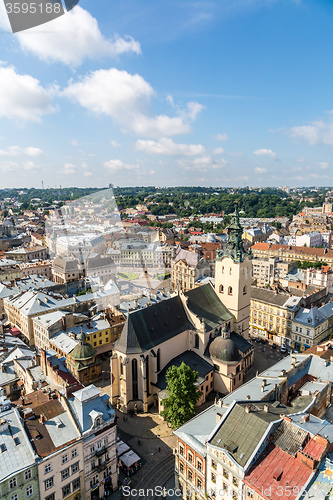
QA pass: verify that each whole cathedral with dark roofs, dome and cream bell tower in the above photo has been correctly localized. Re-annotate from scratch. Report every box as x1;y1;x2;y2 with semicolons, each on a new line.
111;205;253;413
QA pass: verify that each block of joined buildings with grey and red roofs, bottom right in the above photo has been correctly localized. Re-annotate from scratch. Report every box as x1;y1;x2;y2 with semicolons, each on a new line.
174;345;333;500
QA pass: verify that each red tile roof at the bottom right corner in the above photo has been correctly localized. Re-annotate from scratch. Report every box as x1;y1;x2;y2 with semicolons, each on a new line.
244;446;313;500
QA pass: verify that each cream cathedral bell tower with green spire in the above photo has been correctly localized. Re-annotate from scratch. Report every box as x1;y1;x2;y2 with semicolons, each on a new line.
215;203;252;338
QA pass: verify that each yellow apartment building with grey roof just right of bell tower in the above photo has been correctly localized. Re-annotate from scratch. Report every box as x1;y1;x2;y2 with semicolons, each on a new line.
250;287;301;345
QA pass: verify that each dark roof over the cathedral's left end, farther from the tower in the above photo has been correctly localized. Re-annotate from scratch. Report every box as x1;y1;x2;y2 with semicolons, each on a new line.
115;296;193;354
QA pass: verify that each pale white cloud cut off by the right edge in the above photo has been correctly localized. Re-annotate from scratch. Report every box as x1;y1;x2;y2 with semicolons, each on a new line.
289;116;333;146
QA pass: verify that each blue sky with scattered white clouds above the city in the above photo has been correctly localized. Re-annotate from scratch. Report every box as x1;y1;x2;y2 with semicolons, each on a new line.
0;0;333;188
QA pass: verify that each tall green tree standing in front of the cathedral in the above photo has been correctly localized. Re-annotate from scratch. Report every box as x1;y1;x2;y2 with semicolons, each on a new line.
161;363;202;429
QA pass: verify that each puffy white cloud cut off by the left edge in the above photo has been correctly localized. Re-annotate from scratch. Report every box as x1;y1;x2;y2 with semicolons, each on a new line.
0;66;54;122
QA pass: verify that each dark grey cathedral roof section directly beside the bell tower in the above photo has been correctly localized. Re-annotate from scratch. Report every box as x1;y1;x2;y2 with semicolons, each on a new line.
184;283;233;331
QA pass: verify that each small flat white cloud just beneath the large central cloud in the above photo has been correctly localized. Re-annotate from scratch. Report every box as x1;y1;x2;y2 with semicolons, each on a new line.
135;137;205;156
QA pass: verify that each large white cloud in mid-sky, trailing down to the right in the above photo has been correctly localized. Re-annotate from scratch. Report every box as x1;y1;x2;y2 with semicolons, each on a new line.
62;68;203;137
